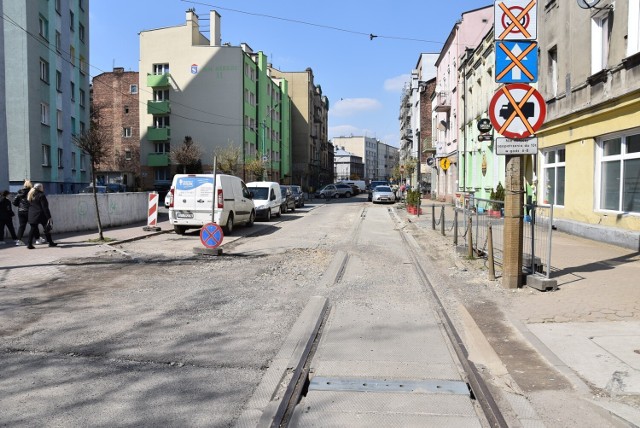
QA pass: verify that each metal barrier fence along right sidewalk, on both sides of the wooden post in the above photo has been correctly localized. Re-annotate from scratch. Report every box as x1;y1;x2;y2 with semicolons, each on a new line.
425;197;553;278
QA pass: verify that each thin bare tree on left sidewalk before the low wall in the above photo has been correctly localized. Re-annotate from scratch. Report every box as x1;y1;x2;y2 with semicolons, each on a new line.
73;107;111;241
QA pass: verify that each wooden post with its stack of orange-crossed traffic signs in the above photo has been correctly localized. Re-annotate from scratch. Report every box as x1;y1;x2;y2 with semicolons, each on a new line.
489;0;546;288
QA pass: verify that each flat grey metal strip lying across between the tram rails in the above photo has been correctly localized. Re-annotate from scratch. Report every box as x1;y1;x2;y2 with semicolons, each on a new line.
309;377;470;395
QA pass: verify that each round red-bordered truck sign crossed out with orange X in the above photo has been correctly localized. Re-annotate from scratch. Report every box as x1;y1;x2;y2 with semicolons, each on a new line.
489;83;547;138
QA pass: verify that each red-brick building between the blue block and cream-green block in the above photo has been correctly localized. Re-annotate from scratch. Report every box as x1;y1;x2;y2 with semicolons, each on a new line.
91;67;140;190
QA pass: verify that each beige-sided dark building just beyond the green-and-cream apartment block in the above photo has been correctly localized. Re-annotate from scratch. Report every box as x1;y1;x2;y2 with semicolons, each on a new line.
269;67;333;189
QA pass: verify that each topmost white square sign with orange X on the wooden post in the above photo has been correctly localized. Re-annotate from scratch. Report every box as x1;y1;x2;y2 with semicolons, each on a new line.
494;0;538;40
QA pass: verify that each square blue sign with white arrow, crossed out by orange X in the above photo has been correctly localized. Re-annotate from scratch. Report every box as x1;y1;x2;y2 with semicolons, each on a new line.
496;41;538;83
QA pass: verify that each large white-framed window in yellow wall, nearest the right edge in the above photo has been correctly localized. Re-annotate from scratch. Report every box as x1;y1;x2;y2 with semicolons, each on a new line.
596;129;640;213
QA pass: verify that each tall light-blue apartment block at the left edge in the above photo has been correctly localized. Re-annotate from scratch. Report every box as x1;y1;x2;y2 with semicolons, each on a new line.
0;0;90;193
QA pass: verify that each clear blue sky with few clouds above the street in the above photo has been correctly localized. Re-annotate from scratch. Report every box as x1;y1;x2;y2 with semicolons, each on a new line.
89;0;493;147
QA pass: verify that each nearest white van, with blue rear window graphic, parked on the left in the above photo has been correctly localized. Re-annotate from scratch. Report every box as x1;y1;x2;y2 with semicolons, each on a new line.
167;174;256;235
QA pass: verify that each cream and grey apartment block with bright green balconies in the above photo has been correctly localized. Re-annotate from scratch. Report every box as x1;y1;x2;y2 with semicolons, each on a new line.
139;9;291;190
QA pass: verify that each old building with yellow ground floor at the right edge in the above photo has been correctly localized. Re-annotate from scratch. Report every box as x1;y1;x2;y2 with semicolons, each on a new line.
537;0;640;242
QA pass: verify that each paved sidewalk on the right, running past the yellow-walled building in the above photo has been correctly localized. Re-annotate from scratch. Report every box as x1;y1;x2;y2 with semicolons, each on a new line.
398;200;640;426
